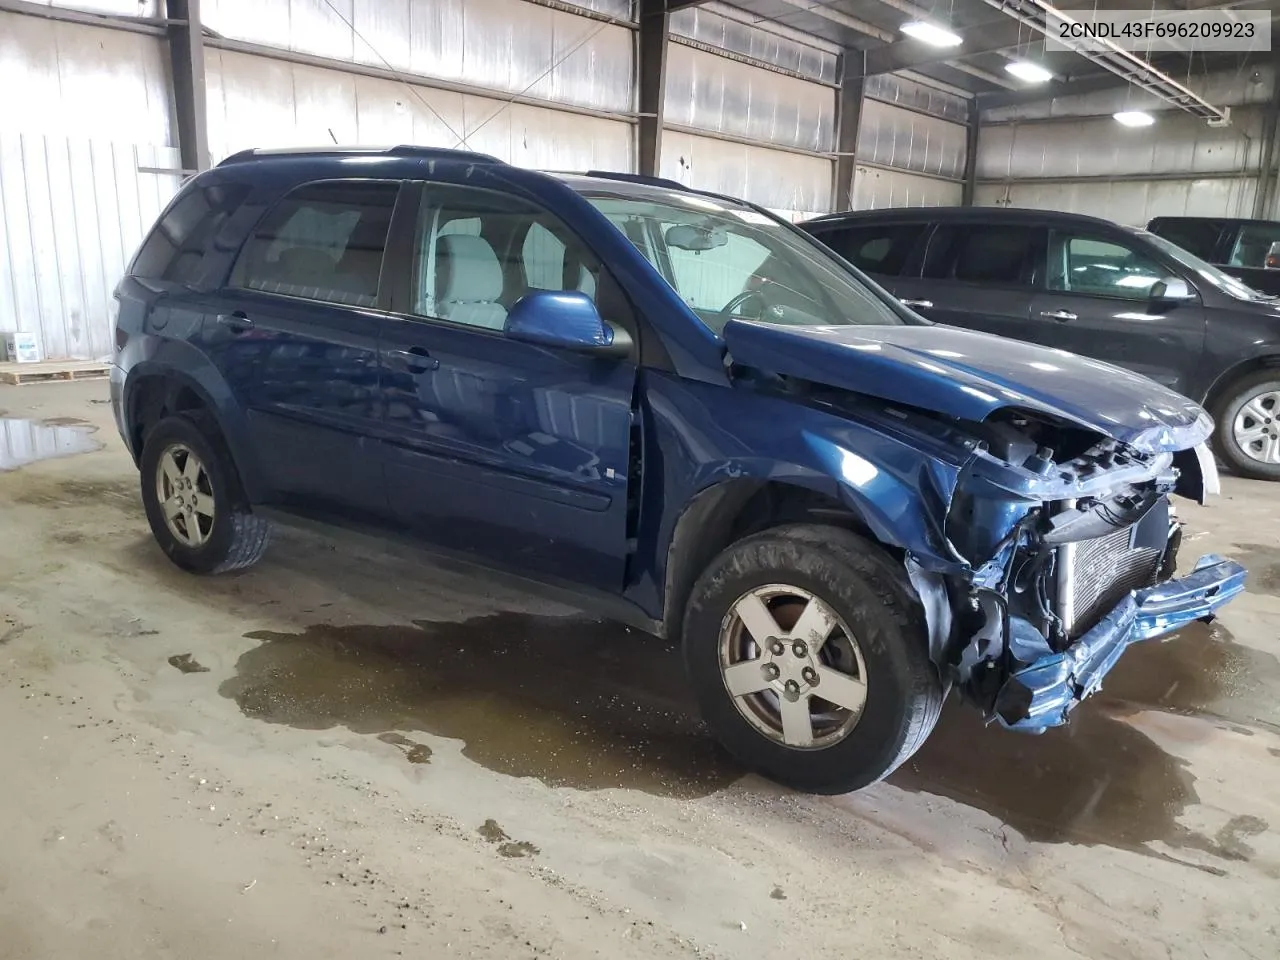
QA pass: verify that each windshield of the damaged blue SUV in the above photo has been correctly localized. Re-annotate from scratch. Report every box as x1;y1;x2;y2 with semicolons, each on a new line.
584;191;905;334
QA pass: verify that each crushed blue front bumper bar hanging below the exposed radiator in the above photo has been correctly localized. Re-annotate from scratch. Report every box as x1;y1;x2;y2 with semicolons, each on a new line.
996;554;1245;733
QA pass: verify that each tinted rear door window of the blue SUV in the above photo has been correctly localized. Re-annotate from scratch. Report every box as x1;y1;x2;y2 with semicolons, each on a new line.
232;180;399;307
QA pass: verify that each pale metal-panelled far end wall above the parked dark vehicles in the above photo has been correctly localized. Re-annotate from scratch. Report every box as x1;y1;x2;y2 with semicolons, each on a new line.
975;69;1272;225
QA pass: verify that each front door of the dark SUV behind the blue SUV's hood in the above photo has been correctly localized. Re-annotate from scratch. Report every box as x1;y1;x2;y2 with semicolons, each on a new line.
1030;229;1204;393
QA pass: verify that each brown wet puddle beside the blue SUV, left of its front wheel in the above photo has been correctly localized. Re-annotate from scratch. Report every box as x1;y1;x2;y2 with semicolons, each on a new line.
221;613;741;797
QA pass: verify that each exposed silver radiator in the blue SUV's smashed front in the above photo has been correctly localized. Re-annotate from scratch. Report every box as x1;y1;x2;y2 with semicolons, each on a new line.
1057;526;1161;640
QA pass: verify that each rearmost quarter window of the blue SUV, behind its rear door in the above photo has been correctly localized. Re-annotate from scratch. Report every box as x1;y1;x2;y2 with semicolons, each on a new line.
131;183;248;284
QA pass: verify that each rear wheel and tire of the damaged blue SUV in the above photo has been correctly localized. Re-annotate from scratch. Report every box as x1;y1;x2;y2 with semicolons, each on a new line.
140;413;271;573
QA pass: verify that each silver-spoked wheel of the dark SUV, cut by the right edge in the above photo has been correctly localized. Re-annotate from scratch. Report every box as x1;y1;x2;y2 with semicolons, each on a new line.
1213;369;1280;480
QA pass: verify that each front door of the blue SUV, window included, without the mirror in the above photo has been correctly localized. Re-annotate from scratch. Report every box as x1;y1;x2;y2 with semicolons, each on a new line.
381;182;639;591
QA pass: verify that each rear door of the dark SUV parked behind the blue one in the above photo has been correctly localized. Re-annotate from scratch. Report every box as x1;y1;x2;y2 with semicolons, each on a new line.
893;221;1048;339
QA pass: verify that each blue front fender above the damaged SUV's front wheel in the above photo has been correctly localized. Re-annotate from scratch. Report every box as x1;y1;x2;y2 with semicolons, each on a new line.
626;370;969;618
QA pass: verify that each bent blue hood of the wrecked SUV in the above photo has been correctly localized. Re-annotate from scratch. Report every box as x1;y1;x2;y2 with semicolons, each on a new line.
723;320;1212;451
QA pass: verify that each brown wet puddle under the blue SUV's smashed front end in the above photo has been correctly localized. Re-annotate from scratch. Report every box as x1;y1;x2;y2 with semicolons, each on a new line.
888;623;1280;860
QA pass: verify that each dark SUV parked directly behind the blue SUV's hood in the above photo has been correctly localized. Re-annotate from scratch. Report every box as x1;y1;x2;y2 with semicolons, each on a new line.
801;207;1280;480
